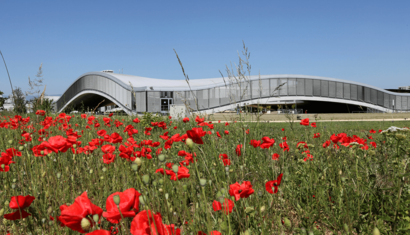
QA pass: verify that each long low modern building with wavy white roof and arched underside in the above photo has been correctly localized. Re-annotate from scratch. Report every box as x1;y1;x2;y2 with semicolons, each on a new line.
56;70;410;114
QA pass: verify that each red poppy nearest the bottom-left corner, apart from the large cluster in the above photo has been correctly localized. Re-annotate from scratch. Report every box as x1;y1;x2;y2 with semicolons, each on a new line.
4;195;36;220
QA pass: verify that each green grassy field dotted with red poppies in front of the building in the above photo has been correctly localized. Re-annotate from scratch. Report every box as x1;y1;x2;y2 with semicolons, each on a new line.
0;111;410;235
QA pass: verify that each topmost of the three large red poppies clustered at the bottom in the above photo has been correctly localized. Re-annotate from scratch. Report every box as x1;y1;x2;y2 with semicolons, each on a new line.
103;188;141;224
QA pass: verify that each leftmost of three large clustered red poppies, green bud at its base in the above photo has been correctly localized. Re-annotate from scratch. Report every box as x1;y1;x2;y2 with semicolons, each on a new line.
58;192;103;233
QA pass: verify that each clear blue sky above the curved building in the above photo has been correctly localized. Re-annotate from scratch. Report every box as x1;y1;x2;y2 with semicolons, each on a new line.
0;0;410;95
